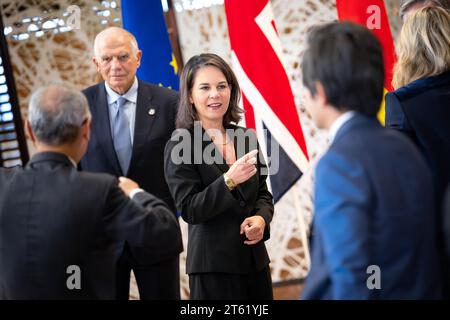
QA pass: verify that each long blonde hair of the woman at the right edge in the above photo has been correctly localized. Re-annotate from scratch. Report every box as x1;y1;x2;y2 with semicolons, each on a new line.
392;7;450;89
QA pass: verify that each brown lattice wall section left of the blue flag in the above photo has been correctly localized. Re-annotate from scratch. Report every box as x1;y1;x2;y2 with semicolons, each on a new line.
1;0;121;154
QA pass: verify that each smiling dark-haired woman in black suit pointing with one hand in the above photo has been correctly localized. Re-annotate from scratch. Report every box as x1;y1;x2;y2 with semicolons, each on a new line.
165;54;273;299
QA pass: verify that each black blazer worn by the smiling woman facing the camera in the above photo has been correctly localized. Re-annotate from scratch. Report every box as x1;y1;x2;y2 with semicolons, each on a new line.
165;124;273;274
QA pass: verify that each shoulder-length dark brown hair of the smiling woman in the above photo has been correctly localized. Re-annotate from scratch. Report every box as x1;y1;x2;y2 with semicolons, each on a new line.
176;53;243;129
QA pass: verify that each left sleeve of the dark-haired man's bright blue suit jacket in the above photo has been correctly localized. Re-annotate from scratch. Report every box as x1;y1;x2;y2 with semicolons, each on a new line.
313;153;376;299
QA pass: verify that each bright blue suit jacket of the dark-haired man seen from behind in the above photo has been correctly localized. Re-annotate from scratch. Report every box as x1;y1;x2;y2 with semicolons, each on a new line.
302;114;442;299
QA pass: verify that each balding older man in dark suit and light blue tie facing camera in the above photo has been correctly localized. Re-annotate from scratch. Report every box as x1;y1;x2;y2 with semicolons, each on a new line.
80;27;183;300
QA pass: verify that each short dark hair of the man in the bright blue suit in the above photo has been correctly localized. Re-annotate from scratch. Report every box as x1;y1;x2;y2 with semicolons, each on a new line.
302;22;384;116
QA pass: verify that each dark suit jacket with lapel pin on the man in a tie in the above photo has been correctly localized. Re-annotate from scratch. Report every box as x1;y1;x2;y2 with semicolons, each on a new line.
80;80;183;298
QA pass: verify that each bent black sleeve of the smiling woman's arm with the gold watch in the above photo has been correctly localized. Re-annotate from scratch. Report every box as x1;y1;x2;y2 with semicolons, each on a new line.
164;140;238;224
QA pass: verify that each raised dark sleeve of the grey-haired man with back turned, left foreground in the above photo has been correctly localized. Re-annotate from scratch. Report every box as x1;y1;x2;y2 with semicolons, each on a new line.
103;181;181;255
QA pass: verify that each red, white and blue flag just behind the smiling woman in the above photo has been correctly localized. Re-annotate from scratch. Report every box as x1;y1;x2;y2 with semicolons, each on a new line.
225;0;308;200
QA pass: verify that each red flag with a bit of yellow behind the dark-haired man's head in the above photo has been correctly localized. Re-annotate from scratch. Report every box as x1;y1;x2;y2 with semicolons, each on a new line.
336;0;397;123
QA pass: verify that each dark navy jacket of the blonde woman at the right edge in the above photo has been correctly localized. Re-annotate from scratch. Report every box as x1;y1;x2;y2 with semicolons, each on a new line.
386;71;450;208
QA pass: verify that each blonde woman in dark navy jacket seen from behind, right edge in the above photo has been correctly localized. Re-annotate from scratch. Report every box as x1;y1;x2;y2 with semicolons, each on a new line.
386;7;450;207
